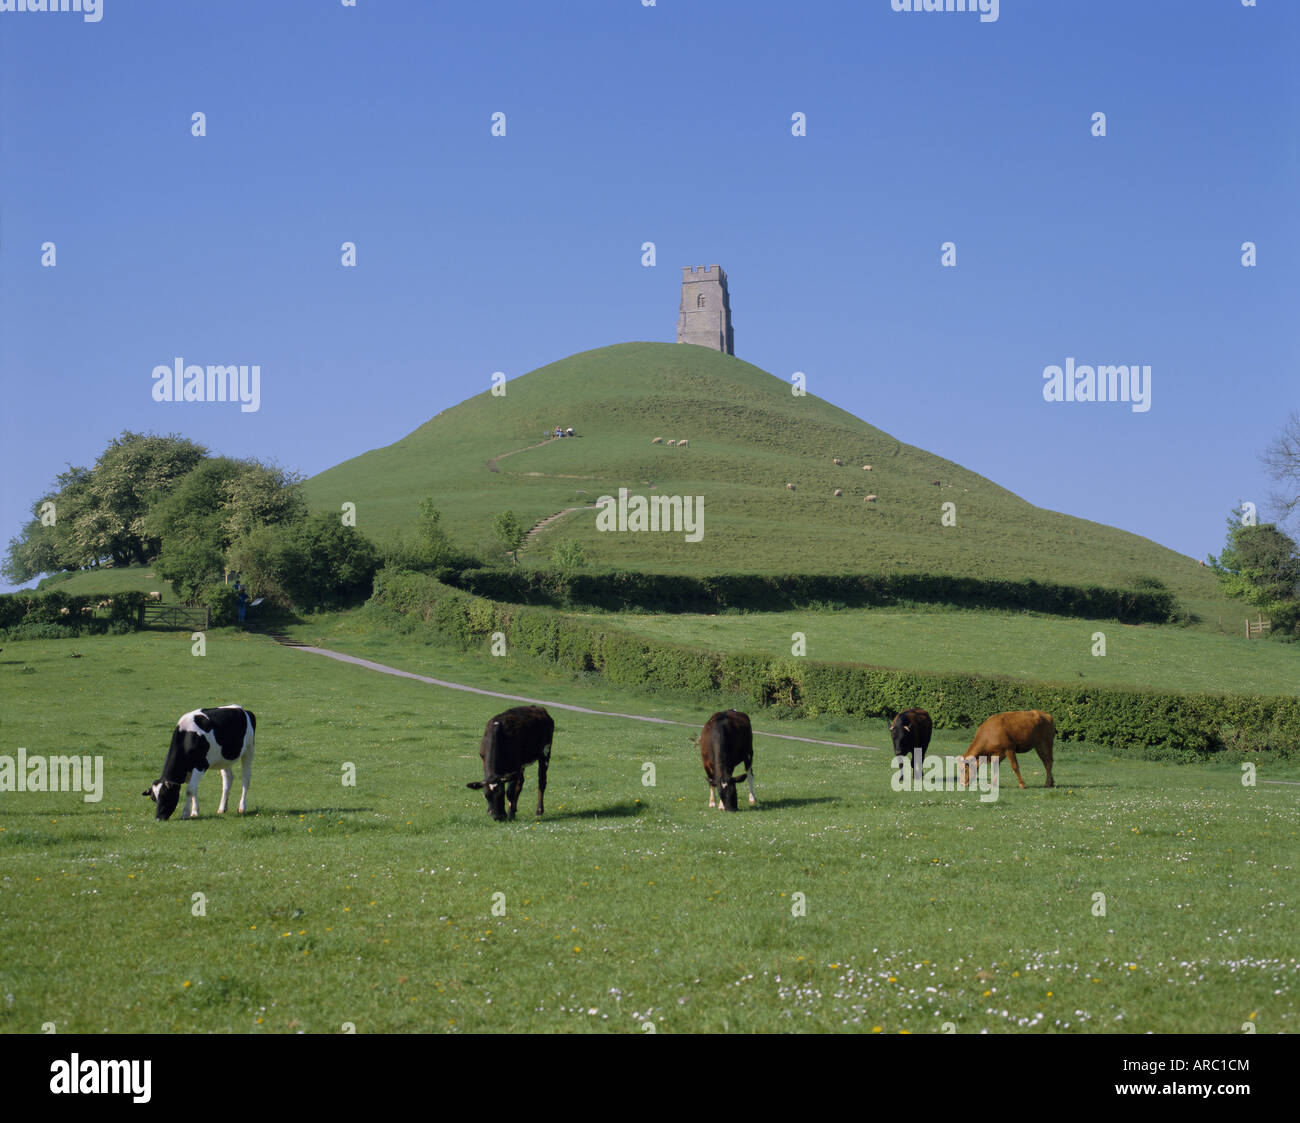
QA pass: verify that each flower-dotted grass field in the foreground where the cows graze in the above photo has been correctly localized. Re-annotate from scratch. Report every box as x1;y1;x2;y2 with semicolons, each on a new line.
0;626;1300;1033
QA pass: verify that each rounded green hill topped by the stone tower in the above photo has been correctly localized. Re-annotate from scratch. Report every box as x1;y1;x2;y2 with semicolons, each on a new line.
307;343;1242;628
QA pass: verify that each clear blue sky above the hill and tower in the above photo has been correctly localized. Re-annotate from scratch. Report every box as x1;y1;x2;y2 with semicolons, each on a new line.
0;0;1300;592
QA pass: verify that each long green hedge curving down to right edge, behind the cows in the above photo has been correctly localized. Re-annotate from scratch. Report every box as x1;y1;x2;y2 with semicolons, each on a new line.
371;569;1300;753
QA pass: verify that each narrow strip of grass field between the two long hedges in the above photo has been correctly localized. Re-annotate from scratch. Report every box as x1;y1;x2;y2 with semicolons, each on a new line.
564;606;1300;694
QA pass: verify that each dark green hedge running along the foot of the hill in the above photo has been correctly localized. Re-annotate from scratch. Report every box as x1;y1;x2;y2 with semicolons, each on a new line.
436;568;1178;624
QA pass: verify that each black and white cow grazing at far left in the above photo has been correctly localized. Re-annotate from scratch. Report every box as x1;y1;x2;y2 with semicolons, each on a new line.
140;706;257;819
